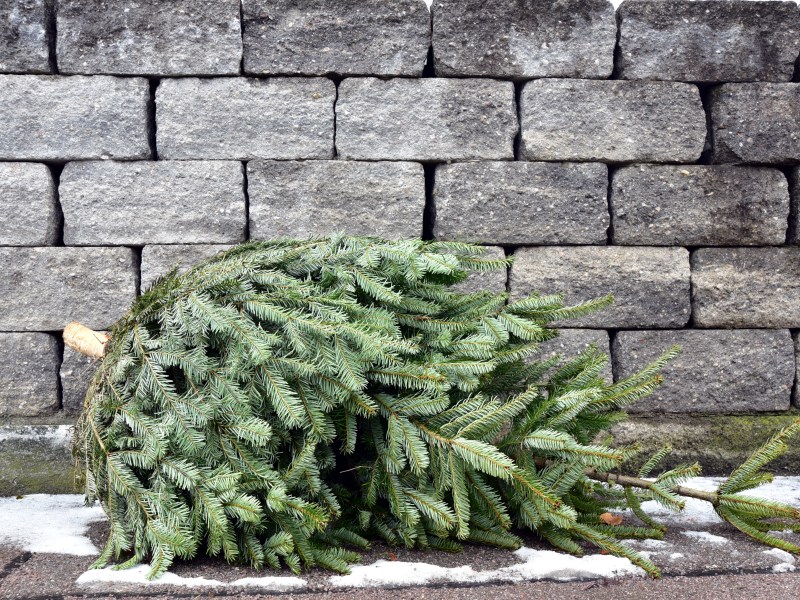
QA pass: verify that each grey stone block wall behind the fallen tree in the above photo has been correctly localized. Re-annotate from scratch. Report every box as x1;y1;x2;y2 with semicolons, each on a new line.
0;0;800;493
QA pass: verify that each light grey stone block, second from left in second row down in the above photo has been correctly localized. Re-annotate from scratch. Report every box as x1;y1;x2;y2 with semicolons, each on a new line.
156;77;336;160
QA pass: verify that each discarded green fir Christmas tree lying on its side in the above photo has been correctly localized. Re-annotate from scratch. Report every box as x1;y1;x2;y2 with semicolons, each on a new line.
68;236;800;577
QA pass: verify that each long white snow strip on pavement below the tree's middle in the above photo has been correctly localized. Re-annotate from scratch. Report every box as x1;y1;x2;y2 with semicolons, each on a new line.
329;548;644;587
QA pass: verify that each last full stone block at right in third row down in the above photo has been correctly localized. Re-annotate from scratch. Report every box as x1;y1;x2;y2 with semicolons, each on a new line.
609;165;789;246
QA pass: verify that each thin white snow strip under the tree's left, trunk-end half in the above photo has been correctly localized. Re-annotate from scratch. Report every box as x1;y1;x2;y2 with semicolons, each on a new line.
75;565;306;592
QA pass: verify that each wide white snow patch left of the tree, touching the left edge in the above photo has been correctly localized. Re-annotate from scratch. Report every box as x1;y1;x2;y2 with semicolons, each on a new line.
0;494;106;556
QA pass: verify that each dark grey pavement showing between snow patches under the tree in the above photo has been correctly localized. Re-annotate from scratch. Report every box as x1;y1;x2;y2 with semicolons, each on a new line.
0;523;800;600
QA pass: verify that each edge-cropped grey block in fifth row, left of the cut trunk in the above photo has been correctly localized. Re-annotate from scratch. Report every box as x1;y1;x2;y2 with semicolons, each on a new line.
0;333;59;417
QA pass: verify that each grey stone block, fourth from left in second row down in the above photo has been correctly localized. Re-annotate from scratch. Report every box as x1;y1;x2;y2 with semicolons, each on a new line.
520;79;706;163
